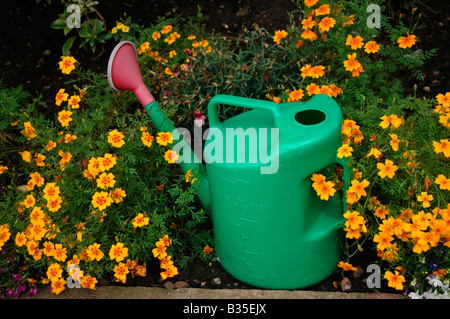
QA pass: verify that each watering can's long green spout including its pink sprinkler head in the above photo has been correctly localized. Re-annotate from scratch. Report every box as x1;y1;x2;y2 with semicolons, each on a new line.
107;41;211;211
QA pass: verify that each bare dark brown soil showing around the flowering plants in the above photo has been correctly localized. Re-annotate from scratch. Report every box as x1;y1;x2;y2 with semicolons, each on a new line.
0;0;450;292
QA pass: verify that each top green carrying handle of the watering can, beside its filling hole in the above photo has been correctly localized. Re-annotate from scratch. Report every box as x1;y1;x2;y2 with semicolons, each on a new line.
208;94;279;127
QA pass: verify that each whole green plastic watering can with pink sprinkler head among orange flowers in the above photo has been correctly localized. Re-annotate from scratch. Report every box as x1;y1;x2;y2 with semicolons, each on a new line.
108;41;350;289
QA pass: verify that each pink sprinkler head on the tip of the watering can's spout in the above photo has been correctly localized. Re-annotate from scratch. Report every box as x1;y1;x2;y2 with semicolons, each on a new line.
107;41;154;106
